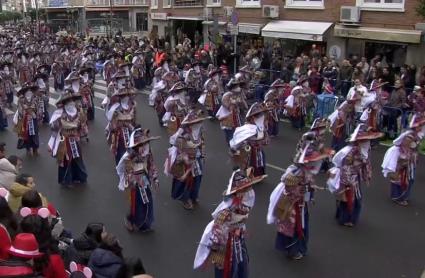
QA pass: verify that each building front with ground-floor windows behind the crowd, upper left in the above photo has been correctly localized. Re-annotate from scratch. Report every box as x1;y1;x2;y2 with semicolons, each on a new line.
47;0;149;36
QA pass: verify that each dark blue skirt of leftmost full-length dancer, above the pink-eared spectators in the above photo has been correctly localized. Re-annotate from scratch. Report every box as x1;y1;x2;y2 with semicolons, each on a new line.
58;157;87;185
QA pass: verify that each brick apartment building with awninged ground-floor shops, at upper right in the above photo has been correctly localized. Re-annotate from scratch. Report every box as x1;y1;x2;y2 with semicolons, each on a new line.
150;0;425;65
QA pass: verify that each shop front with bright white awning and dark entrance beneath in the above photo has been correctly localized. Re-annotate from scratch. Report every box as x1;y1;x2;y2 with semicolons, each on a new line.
261;20;333;57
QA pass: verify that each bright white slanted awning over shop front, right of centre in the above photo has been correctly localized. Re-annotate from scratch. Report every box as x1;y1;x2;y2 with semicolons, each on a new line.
261;20;333;41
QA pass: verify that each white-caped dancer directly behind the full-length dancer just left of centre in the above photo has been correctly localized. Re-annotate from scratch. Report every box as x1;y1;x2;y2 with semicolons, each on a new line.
162;81;188;135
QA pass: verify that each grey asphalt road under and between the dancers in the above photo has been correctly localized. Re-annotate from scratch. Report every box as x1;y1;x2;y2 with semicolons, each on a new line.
0;79;425;278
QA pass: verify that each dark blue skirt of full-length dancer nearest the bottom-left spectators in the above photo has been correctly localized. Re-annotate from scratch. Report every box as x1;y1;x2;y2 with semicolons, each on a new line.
127;186;154;231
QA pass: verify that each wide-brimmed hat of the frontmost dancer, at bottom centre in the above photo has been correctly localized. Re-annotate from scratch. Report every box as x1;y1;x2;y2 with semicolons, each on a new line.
223;167;267;196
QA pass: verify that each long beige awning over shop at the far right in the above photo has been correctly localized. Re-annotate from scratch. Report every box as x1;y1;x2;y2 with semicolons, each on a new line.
334;25;422;43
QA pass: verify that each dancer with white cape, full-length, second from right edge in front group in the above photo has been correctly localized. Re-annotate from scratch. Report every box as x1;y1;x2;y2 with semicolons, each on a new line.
327;124;384;227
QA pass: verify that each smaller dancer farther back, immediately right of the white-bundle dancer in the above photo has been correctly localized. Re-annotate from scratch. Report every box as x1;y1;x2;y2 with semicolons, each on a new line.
264;79;285;137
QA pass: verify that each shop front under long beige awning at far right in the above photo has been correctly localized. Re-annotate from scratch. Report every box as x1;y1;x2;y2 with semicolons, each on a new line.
334;25;425;67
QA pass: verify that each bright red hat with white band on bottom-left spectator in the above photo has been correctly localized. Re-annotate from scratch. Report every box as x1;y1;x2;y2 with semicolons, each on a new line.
8;233;43;259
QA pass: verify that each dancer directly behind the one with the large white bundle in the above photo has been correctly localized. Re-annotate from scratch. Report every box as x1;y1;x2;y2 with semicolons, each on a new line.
215;78;248;144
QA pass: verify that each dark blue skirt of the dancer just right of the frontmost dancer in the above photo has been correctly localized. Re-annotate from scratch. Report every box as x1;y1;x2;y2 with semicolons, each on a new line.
275;207;309;257
